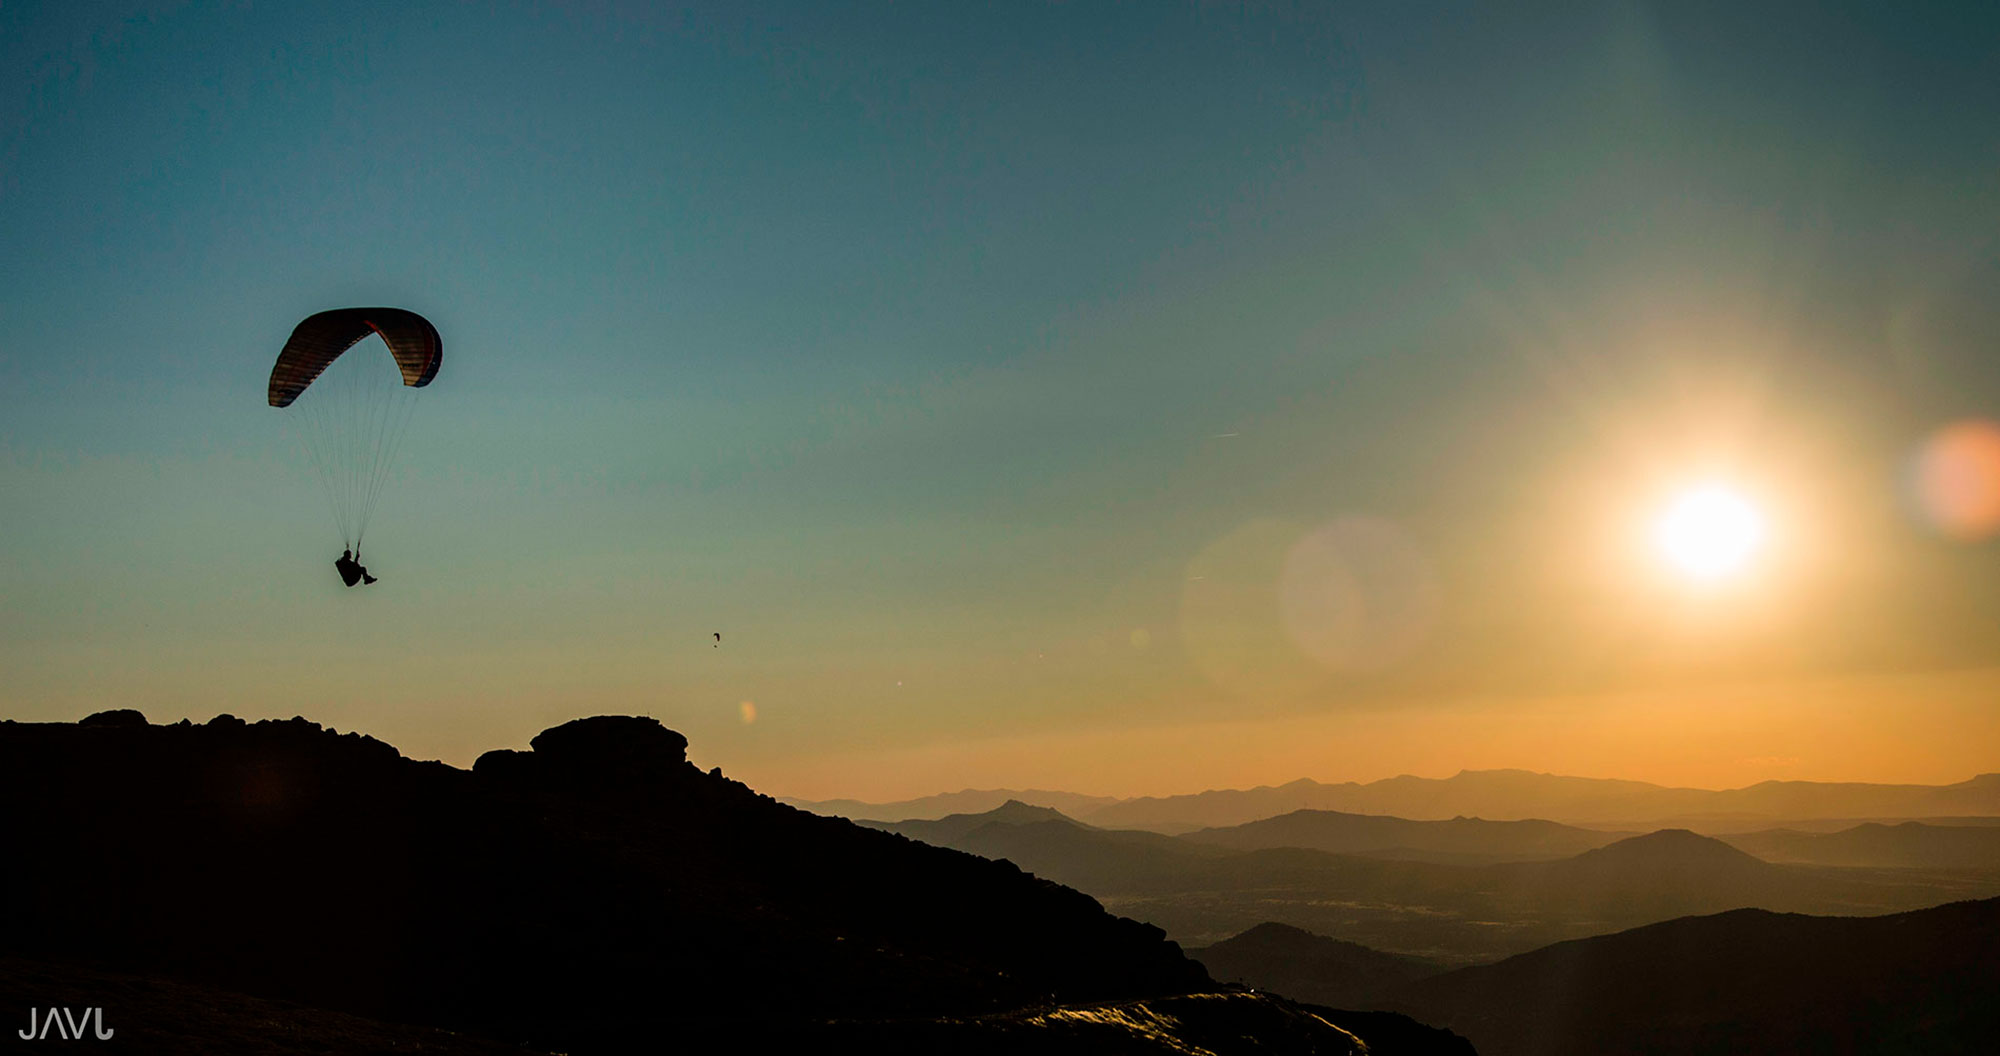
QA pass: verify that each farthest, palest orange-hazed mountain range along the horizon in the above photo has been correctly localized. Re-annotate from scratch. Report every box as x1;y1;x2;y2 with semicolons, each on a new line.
788;770;2000;834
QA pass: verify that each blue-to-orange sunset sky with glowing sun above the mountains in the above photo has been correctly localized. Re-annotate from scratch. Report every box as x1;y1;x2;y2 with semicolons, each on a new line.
0;0;2000;800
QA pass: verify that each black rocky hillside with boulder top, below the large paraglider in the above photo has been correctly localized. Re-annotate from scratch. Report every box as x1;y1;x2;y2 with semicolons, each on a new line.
0;712;1456;1052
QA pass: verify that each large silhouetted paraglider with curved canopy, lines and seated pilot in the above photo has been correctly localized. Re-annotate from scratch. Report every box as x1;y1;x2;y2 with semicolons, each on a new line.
268;308;444;586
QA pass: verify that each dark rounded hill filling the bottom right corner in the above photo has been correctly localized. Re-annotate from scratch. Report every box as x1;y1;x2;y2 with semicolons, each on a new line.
1384;900;2000;1056
